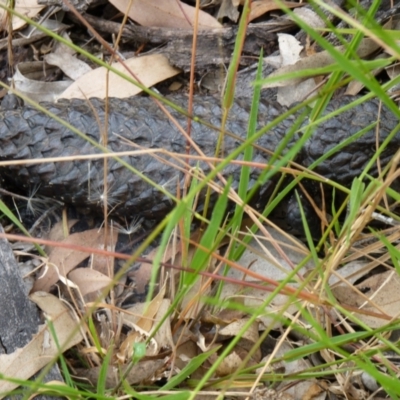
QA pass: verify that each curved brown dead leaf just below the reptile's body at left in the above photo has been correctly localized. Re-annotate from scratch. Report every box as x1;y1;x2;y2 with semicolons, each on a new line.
32;229;115;292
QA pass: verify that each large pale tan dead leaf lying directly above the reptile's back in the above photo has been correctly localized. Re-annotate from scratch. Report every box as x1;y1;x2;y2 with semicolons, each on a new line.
60;54;180;99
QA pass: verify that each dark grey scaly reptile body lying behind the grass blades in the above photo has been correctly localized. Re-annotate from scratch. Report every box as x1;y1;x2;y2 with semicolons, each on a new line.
0;95;400;236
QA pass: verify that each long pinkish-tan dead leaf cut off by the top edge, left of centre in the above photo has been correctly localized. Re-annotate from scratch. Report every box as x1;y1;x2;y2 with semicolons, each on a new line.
110;0;222;29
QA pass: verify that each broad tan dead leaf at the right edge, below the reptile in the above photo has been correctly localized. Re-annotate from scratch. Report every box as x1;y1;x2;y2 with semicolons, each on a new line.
332;270;400;328
